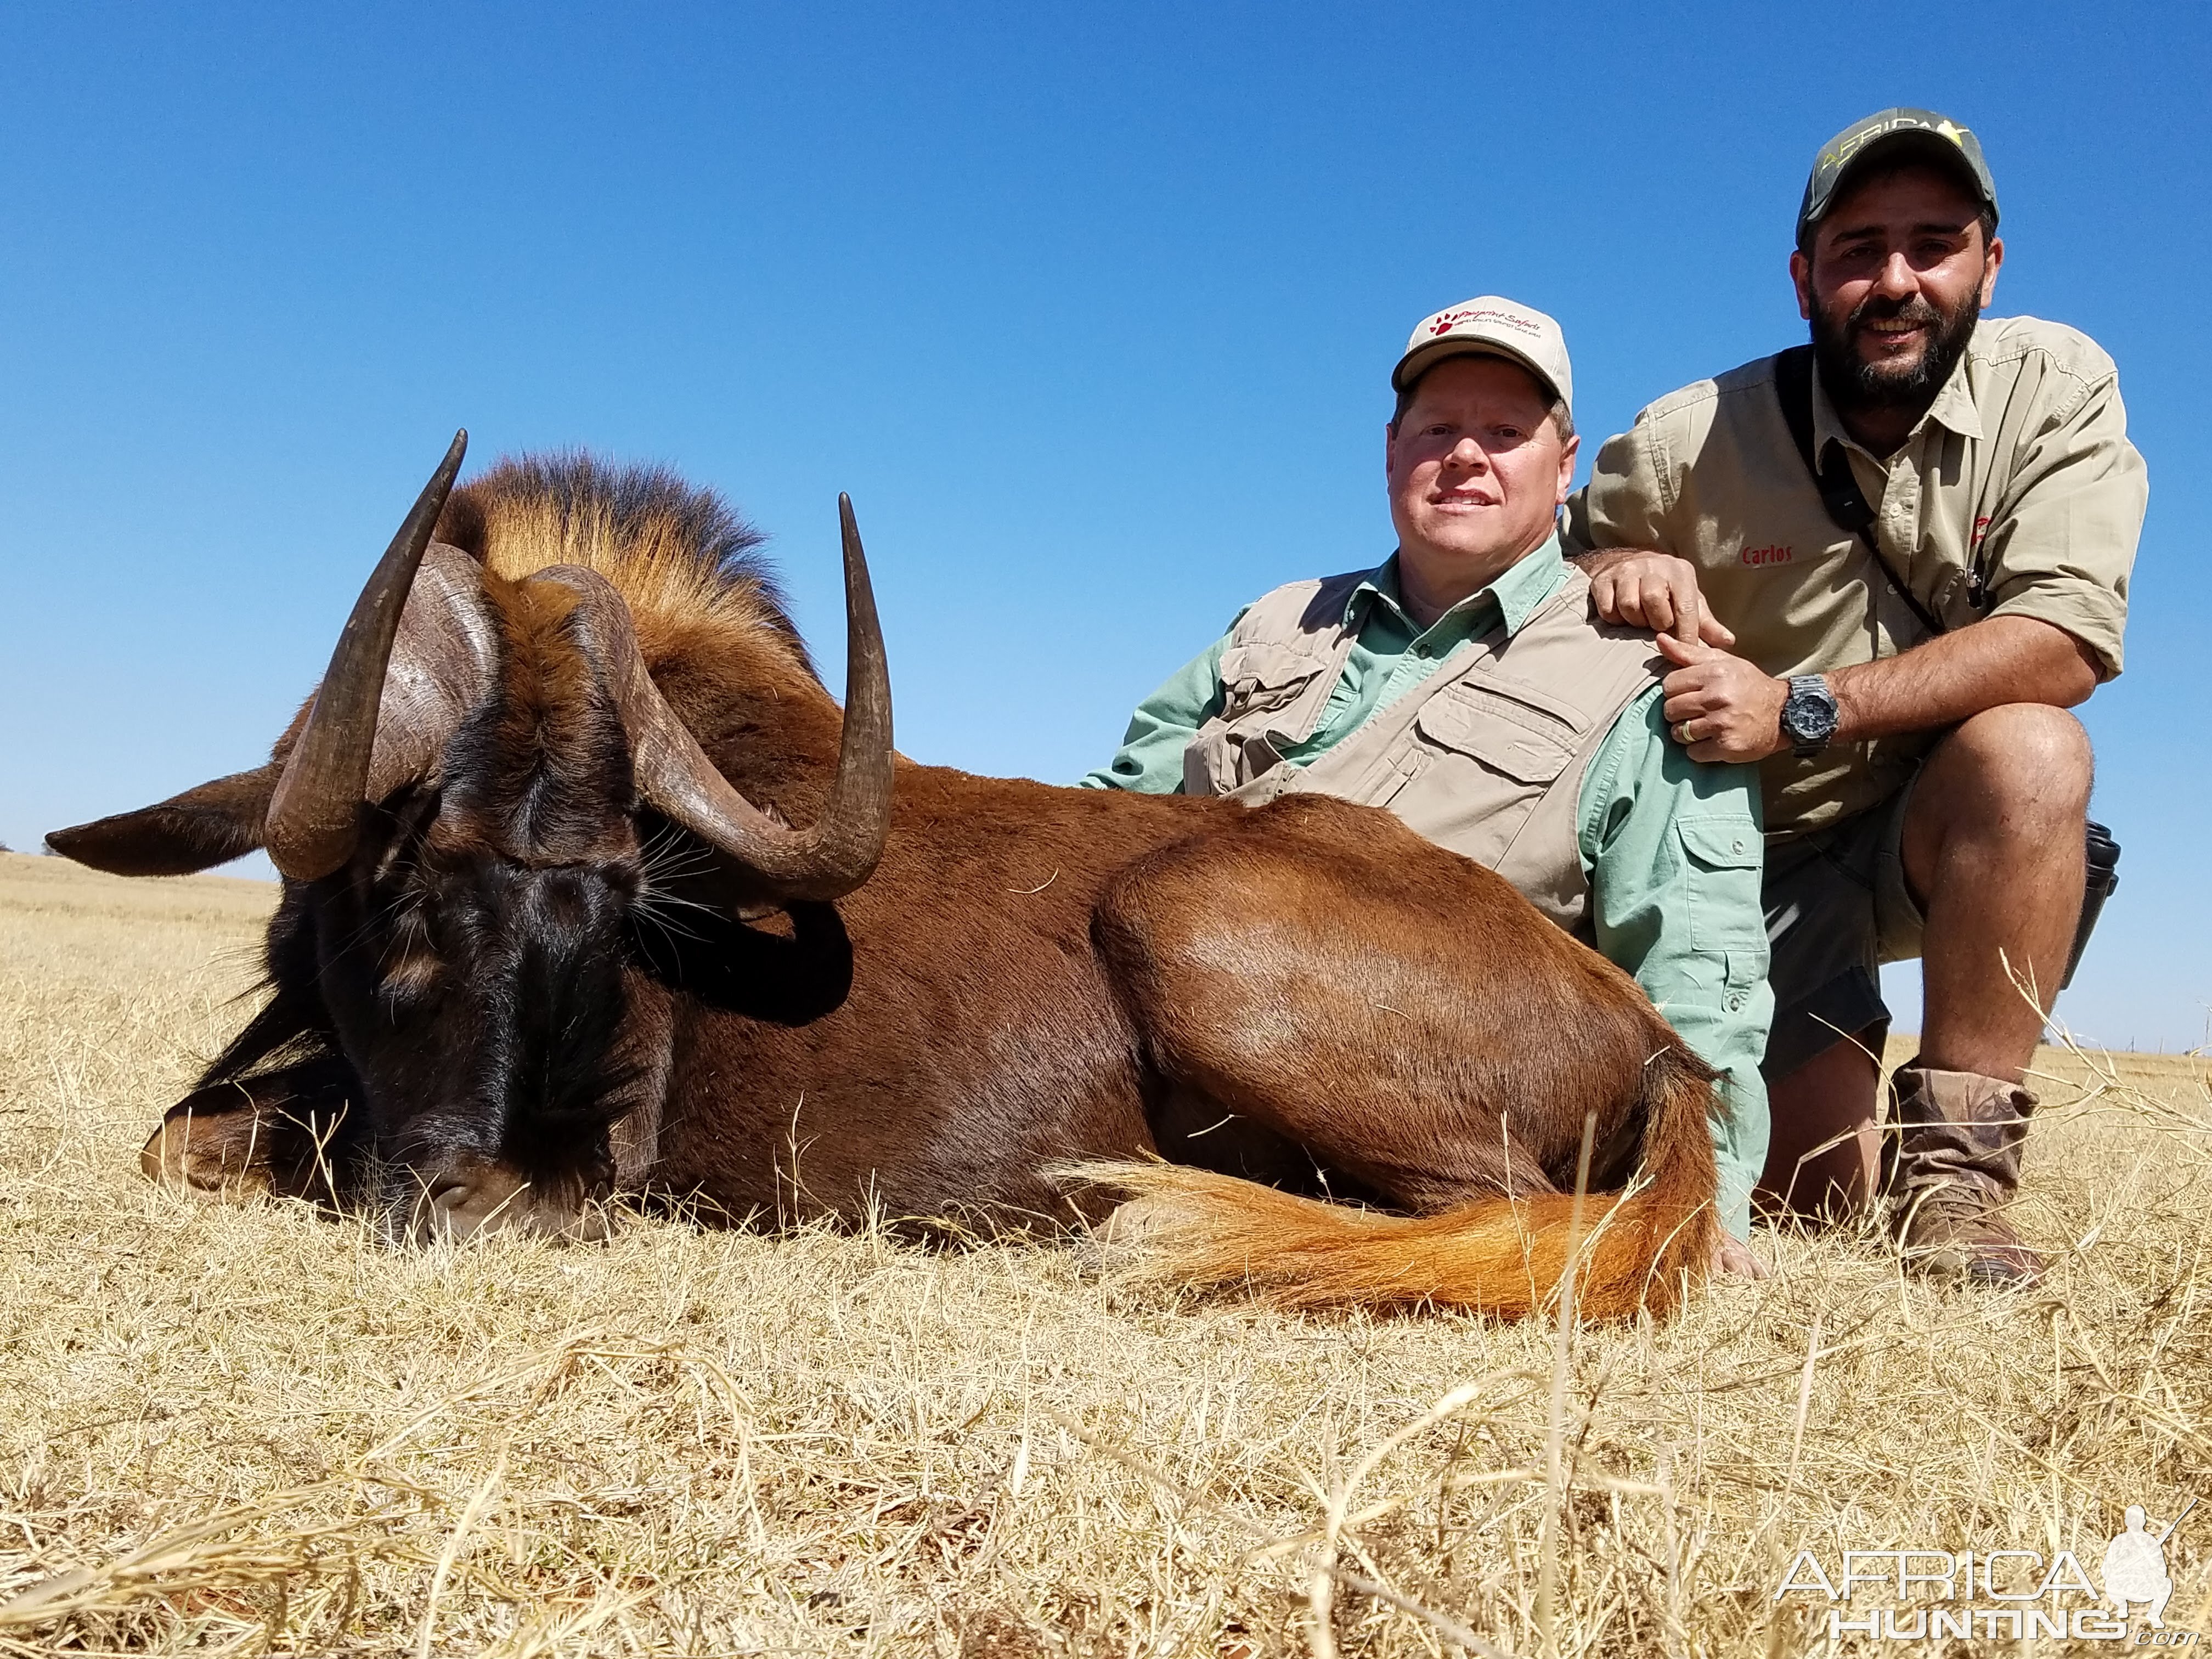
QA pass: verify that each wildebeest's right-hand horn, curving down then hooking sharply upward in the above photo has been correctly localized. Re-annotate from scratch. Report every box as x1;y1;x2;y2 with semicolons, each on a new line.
544;495;891;902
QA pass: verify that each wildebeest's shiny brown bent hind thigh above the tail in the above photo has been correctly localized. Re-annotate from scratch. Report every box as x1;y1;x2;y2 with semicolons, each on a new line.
1097;797;1652;1210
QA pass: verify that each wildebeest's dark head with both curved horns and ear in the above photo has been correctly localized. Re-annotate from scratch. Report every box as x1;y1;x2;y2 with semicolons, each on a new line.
49;436;891;1237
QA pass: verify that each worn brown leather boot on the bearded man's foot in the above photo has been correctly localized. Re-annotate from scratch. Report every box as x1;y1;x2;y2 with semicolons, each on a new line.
1882;1064;2044;1288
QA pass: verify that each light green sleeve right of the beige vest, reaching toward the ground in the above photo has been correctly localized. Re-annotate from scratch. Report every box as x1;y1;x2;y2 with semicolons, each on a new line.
1579;686;1774;1239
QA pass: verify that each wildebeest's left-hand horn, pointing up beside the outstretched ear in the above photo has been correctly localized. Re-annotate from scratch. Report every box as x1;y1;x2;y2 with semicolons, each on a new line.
268;431;469;881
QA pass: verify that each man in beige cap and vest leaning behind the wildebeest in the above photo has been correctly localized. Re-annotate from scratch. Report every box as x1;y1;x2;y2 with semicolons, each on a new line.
1084;296;1772;1272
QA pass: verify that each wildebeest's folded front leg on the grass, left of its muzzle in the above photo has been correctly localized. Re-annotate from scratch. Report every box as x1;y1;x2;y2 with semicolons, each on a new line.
139;1073;345;1203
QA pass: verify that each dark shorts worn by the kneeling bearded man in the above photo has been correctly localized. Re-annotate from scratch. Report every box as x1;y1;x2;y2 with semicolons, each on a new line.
1758;783;1920;1084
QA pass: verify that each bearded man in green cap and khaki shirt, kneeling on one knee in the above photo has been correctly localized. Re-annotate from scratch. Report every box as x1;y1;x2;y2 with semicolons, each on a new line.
1566;109;2146;1283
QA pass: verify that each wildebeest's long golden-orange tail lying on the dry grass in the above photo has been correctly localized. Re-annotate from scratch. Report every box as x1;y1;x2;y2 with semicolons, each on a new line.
1068;1046;1719;1318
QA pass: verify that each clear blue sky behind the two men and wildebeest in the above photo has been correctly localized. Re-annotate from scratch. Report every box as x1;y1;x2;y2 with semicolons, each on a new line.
0;4;2212;1048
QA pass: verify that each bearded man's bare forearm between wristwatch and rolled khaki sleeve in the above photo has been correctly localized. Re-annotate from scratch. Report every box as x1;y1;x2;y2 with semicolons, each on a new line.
1827;617;2097;743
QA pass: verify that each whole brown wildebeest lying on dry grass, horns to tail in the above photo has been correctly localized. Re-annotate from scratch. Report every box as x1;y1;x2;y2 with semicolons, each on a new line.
51;440;1717;1314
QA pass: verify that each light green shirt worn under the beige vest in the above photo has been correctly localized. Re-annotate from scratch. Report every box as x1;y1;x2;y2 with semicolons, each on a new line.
1084;540;1774;1239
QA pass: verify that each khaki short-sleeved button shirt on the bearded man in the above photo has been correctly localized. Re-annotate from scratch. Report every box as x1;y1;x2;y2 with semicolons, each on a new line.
1566;317;2148;834
